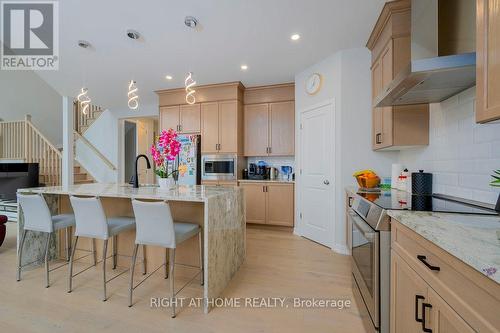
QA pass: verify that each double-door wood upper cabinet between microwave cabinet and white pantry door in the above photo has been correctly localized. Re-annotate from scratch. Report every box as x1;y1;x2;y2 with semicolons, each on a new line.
244;84;295;156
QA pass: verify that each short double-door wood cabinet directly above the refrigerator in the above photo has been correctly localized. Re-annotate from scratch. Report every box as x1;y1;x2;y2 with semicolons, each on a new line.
160;104;201;134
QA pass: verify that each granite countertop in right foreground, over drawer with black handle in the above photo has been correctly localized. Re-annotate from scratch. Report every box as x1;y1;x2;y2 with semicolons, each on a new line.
387;210;500;283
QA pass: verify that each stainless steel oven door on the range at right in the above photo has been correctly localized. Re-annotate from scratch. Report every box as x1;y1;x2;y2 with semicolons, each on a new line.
349;209;380;328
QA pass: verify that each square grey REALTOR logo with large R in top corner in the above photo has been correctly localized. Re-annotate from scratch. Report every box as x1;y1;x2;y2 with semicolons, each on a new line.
0;1;59;70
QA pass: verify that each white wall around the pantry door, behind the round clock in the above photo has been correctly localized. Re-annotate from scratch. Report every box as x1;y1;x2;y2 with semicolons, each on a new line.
295;48;398;253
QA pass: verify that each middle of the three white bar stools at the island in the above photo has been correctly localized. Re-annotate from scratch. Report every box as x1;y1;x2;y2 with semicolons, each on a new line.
68;196;140;301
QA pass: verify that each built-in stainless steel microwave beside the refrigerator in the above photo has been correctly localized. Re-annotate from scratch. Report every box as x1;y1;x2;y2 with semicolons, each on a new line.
201;155;237;180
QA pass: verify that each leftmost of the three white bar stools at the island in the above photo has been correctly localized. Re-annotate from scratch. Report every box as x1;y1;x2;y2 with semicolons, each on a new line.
17;193;75;288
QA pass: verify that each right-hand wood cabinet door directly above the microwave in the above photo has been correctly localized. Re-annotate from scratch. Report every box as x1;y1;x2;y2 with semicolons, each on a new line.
219;101;238;153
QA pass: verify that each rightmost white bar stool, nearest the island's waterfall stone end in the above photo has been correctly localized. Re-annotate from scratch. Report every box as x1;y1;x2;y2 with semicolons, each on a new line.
129;200;203;318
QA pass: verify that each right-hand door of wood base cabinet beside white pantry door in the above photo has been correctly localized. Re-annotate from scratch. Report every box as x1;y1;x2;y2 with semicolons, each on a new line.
266;183;294;227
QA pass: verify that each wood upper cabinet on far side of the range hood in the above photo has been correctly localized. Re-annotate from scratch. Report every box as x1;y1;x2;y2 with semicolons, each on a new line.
366;0;429;150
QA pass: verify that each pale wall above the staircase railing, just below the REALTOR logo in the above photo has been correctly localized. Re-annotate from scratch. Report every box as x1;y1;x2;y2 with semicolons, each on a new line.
0;71;62;147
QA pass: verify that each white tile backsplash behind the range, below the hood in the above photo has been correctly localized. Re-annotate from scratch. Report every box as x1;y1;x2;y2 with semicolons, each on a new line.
399;87;500;204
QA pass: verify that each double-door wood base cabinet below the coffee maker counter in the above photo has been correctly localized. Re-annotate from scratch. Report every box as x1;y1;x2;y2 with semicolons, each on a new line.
240;182;294;227
